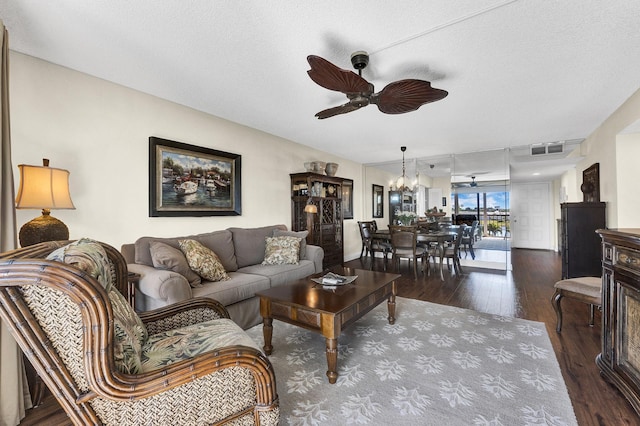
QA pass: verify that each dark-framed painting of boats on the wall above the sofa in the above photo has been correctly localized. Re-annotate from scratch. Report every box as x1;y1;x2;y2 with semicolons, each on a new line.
149;136;242;217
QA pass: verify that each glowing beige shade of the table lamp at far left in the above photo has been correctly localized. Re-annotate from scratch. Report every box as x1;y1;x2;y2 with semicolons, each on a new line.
16;164;75;209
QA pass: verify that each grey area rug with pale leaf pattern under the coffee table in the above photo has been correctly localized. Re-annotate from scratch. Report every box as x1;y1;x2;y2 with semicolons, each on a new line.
248;298;577;426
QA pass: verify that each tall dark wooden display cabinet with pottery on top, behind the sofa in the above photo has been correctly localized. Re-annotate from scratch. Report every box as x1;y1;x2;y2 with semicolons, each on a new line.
290;173;345;268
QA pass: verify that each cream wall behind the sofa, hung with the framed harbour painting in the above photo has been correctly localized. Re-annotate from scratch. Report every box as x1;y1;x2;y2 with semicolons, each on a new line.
10;51;364;259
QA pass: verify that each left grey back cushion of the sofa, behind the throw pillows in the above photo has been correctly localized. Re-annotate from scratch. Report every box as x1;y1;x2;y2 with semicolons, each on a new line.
135;230;238;271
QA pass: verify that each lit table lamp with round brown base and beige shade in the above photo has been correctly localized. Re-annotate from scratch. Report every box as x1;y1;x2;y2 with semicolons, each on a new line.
16;158;75;247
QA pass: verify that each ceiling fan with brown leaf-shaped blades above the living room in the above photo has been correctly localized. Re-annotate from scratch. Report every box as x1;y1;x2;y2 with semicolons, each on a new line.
307;51;449;119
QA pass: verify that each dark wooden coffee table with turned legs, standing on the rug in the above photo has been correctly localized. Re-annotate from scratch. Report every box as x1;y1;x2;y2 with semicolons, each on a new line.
256;267;400;383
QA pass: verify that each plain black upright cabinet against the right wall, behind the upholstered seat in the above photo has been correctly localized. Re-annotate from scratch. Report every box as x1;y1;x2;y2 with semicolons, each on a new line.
560;202;606;279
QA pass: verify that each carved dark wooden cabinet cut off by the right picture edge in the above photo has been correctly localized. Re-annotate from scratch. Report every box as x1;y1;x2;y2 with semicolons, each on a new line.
596;229;640;414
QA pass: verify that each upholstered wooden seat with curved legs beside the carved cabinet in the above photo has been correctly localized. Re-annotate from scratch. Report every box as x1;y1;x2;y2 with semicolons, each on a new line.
551;277;602;333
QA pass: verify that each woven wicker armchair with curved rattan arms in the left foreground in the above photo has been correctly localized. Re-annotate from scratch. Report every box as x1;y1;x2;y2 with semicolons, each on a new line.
0;241;279;426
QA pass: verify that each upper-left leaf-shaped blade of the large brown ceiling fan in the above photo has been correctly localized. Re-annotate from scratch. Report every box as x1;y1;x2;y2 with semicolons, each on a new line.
307;55;373;94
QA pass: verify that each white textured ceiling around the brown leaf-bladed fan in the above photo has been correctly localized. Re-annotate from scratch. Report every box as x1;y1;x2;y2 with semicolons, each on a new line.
0;0;640;181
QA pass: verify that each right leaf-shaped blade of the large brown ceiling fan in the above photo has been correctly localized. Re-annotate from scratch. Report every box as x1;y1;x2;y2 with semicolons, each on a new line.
371;79;449;114
